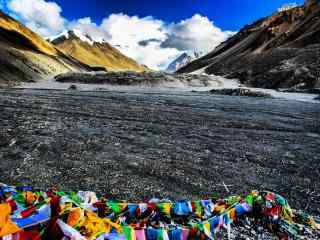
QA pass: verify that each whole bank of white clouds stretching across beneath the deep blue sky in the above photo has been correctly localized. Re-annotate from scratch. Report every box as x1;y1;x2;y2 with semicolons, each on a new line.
0;0;232;69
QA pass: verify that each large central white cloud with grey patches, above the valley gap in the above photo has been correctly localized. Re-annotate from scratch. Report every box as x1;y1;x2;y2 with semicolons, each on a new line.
97;14;231;69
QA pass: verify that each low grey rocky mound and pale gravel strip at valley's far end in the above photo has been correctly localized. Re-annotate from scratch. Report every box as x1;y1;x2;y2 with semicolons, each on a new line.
50;71;320;103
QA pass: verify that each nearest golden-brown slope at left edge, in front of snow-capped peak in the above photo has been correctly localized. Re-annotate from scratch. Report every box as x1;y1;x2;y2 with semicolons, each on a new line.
0;11;89;86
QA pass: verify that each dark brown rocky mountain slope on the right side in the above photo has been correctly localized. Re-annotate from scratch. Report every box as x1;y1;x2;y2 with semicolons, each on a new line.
178;0;320;89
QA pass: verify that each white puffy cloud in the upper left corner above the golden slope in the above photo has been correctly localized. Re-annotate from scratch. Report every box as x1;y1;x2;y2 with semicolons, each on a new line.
7;0;66;37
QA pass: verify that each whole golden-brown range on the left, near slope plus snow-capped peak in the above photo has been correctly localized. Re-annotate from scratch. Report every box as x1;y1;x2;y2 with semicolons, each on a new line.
0;11;148;86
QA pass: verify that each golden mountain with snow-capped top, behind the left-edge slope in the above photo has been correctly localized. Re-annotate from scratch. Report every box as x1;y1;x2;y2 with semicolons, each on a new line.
51;30;148;72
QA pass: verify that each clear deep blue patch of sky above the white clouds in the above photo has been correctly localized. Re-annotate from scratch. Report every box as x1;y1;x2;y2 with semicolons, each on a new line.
56;0;303;31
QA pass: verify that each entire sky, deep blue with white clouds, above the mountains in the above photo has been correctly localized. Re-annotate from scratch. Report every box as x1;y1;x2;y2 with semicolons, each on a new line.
0;0;303;69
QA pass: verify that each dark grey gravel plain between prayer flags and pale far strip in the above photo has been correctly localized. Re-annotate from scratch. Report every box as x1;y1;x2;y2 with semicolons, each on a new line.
0;87;320;218
